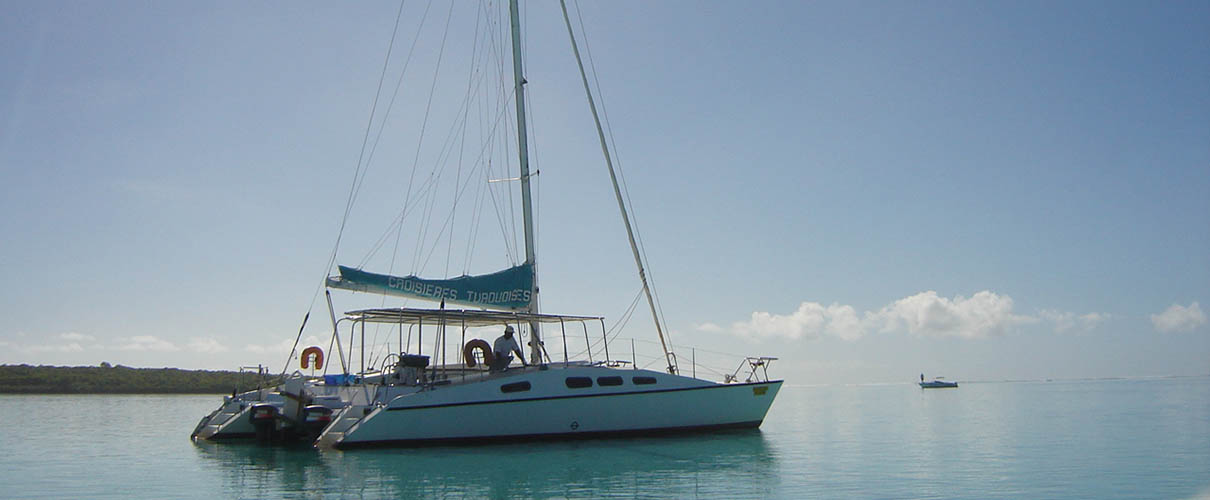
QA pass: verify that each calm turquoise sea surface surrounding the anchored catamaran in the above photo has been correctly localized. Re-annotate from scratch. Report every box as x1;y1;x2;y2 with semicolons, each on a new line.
0;377;1210;499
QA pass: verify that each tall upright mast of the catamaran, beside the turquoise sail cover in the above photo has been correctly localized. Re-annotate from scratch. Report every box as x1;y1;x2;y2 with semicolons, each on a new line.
508;0;542;363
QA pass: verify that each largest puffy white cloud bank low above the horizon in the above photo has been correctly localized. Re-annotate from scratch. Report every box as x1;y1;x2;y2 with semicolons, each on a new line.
726;291;1030;340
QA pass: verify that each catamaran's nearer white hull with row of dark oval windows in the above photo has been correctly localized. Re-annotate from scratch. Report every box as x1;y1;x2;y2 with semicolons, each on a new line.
319;367;782;449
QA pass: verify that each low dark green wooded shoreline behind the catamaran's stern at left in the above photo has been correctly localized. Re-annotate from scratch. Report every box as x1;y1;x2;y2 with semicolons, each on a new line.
0;363;276;395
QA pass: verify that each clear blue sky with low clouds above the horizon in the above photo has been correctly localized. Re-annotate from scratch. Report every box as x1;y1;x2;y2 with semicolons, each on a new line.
0;1;1210;383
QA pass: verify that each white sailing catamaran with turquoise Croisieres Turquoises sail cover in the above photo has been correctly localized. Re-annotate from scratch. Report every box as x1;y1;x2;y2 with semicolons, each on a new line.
192;0;782;449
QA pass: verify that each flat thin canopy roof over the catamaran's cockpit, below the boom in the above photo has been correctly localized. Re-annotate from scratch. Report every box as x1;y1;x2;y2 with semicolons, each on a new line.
345;308;605;327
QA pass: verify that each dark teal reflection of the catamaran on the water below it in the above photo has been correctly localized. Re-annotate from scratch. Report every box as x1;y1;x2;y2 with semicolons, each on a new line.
188;430;779;498
